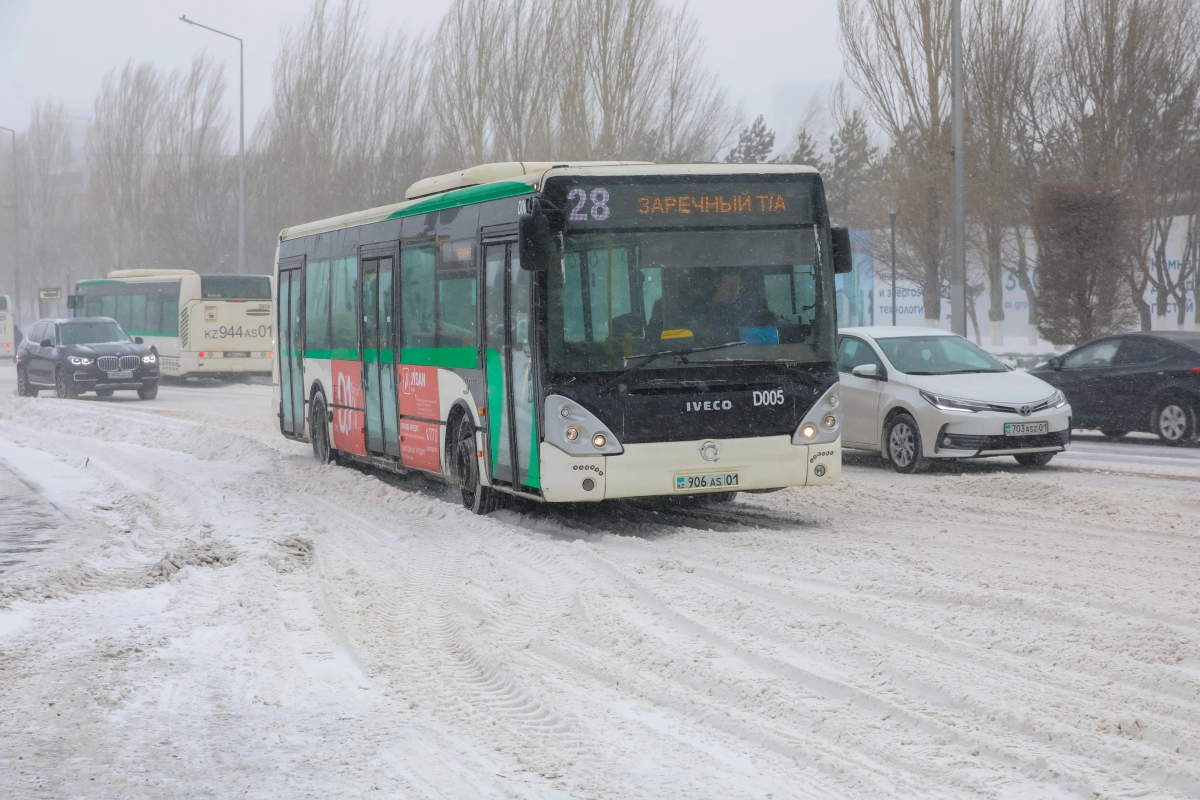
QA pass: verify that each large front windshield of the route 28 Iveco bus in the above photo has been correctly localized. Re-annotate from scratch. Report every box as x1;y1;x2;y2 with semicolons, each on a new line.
550;224;834;373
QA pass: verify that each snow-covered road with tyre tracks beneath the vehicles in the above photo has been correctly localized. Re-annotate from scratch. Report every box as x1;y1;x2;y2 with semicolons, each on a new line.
0;365;1200;799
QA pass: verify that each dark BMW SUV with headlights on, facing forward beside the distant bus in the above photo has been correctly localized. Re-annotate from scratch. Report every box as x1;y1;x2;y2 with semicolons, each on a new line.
17;317;158;399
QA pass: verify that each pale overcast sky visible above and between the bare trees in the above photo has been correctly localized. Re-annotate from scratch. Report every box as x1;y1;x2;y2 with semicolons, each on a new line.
0;0;841;144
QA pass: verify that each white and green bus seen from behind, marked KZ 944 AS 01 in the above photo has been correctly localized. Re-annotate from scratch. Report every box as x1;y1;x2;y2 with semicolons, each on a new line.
72;270;275;378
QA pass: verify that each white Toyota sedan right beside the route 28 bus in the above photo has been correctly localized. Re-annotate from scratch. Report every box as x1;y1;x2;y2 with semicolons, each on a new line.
838;326;1070;473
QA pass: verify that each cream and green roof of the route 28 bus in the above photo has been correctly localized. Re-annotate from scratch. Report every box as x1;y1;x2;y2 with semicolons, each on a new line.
280;161;817;241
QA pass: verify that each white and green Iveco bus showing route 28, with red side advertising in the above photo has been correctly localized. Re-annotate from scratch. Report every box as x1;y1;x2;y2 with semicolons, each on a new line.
272;162;851;513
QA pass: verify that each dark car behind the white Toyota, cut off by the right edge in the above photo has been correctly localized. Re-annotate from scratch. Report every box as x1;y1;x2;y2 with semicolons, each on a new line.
1030;331;1200;445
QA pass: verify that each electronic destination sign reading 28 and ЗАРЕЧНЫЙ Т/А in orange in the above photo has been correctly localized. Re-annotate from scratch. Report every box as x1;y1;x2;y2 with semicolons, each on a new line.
546;176;812;229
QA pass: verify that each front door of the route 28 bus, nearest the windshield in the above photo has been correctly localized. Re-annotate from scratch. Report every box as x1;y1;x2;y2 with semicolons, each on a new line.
482;242;540;488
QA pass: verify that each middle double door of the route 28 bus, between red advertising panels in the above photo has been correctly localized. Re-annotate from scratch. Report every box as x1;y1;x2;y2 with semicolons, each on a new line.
359;253;400;457
